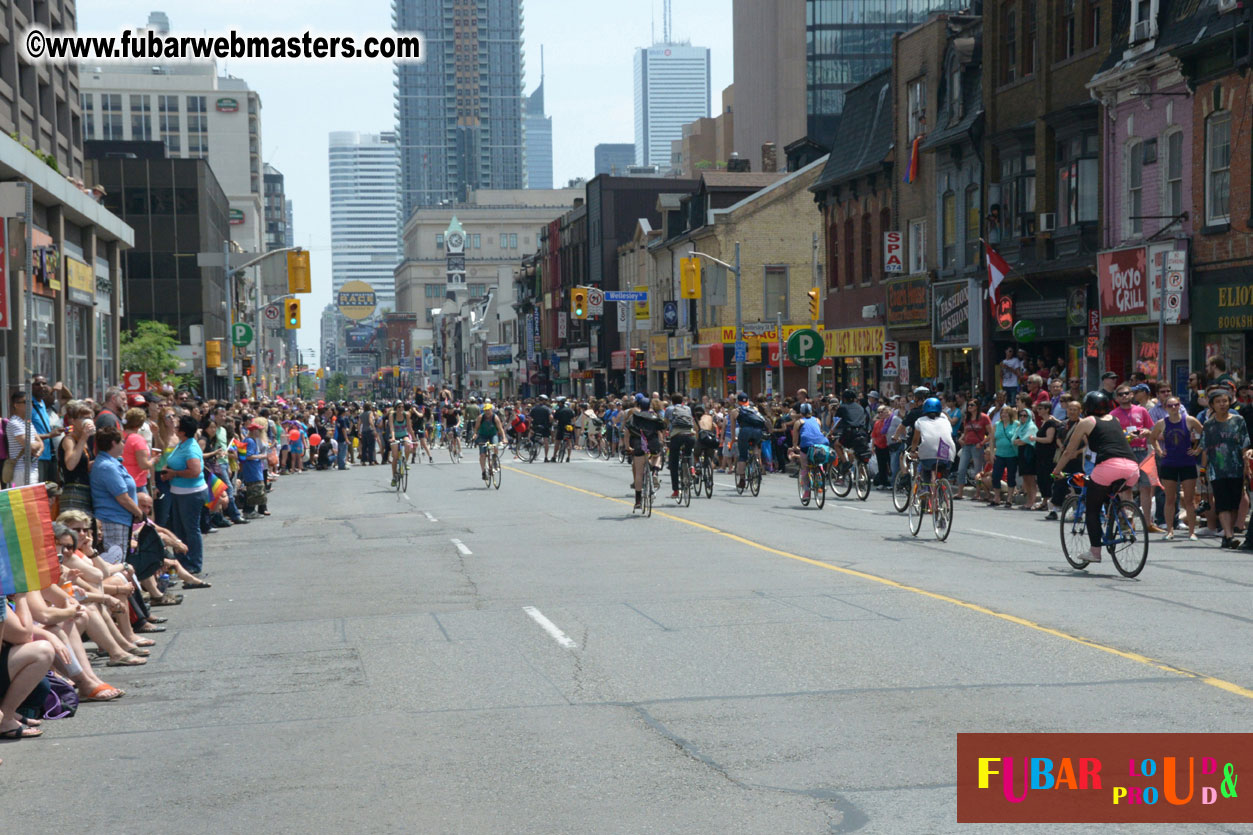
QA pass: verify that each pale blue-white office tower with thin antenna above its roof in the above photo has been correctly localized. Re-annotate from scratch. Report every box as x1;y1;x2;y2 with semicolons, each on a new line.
635;43;710;171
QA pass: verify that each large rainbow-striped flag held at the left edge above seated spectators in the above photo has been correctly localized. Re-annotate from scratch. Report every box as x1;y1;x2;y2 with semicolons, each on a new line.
0;484;61;594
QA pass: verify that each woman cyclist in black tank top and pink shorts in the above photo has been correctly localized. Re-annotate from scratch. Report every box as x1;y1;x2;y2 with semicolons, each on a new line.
1053;391;1140;563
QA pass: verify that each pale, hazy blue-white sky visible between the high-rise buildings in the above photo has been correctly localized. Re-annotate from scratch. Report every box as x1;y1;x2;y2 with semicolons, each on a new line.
78;0;732;363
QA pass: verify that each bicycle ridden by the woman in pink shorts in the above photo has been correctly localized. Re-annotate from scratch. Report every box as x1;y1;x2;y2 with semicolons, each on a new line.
1061;474;1149;577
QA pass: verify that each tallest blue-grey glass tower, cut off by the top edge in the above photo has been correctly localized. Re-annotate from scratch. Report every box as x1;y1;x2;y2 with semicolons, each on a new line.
392;0;526;218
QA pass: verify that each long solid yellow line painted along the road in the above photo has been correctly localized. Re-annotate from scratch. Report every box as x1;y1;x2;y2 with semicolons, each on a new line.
505;466;1253;698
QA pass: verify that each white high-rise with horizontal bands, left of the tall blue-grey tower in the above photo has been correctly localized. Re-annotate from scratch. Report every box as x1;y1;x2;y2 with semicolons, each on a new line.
330;130;401;311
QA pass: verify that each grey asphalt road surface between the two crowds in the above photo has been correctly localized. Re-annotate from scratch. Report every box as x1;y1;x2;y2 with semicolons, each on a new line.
7;448;1253;834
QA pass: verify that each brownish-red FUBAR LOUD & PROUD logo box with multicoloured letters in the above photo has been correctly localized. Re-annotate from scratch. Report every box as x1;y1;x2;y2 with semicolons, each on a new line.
957;733;1253;824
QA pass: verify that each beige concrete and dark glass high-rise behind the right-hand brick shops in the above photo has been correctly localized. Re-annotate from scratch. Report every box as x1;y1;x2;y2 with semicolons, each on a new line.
730;0;971;171
